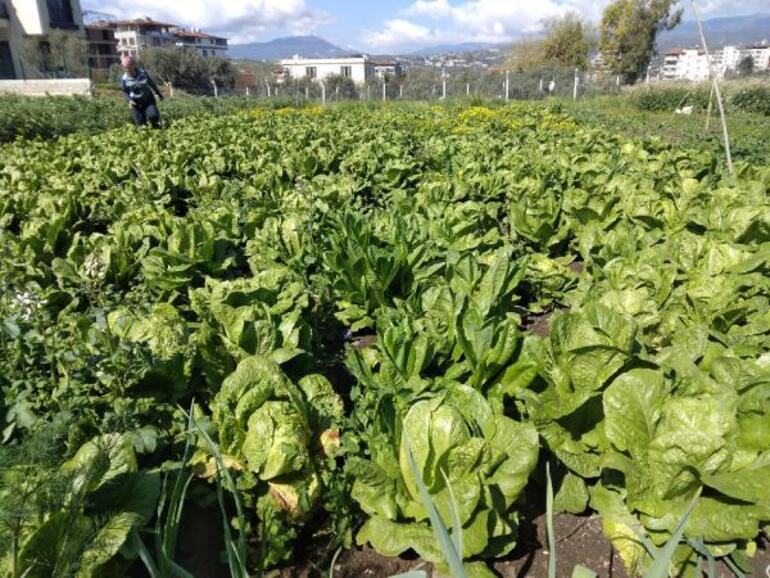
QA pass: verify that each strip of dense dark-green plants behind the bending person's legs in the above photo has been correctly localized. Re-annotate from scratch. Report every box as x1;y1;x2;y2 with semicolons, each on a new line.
0;95;270;142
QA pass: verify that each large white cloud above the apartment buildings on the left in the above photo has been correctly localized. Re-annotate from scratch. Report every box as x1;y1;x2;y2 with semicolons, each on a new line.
83;0;330;43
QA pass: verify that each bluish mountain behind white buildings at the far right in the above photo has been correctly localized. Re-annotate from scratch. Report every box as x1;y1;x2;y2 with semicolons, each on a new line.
658;14;770;52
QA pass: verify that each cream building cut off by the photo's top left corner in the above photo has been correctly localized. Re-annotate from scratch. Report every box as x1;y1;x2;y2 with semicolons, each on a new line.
0;0;84;79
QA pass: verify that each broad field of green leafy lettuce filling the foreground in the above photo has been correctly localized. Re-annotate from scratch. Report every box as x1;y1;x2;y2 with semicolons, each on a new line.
0;104;770;578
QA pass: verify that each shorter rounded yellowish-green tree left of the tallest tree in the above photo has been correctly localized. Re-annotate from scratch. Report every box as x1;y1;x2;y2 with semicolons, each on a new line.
542;12;591;70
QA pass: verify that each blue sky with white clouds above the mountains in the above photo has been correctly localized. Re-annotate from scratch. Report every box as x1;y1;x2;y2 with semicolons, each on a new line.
81;0;770;52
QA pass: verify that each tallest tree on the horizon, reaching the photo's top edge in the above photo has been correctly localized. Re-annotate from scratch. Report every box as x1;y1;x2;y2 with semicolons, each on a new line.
599;0;682;84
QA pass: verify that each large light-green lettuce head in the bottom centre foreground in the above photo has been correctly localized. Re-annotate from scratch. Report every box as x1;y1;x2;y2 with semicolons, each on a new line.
353;383;538;562
